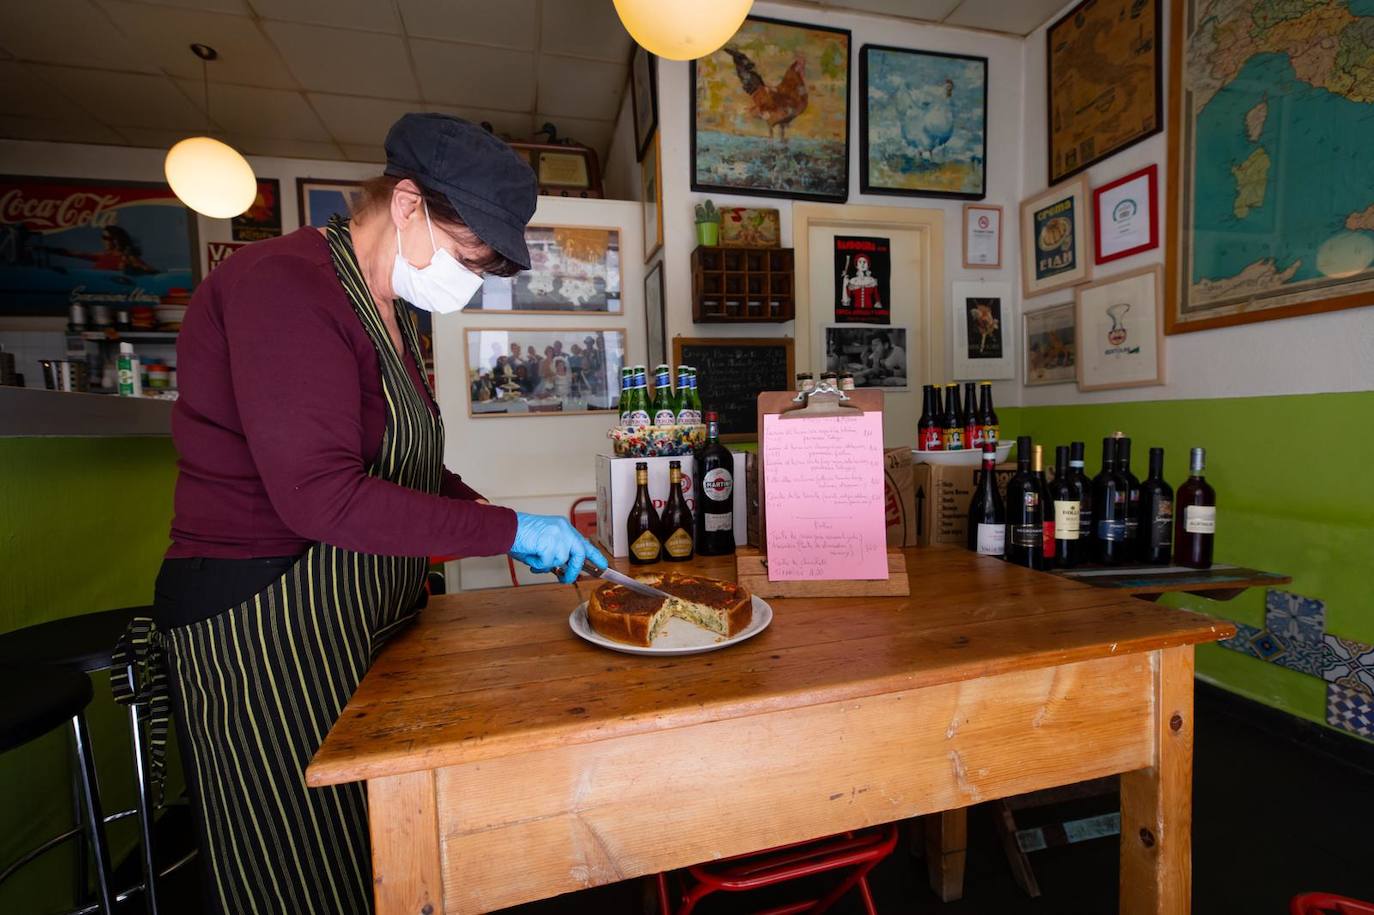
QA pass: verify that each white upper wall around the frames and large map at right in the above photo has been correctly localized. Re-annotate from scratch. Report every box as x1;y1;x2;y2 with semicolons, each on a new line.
1007;3;1374;405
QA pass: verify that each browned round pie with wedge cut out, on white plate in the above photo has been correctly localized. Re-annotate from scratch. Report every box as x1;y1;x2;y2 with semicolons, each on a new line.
587;572;754;648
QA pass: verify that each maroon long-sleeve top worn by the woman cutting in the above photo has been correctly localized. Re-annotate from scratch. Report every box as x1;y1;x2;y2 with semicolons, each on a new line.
168;228;515;559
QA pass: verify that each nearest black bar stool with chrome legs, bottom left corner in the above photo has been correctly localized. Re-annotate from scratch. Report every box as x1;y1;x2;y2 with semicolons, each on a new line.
0;664;114;915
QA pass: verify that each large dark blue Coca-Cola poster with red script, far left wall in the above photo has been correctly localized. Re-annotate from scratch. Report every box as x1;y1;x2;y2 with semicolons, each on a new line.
0;176;196;316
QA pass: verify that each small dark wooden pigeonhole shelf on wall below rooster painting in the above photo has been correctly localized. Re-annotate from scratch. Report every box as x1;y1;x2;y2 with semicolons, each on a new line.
691;245;796;324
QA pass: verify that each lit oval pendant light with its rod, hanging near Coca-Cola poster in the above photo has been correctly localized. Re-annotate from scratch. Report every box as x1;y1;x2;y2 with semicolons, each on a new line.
162;44;257;220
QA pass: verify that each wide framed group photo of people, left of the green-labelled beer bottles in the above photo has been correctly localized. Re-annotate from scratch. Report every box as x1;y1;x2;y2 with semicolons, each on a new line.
463;327;625;416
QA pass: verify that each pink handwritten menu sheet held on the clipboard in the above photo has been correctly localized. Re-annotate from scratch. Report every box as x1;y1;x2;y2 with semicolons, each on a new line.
763;411;888;581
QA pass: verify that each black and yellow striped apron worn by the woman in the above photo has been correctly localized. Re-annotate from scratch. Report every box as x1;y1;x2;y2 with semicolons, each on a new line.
115;223;444;915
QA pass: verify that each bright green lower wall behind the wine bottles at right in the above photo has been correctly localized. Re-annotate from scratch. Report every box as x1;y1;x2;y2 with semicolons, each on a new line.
1009;392;1374;724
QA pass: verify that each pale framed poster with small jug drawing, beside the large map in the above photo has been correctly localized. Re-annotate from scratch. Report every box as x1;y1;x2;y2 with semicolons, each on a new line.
1074;265;1164;390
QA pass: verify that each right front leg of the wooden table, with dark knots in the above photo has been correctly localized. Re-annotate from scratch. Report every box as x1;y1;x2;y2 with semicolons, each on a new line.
1120;646;1193;915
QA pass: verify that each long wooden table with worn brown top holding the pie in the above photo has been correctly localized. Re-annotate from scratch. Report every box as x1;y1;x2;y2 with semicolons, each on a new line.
306;547;1234;915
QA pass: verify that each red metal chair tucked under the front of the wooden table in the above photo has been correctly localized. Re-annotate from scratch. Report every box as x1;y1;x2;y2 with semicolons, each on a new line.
658;823;897;915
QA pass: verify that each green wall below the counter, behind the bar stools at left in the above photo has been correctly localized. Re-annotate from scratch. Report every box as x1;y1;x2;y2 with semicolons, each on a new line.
0;438;180;912
